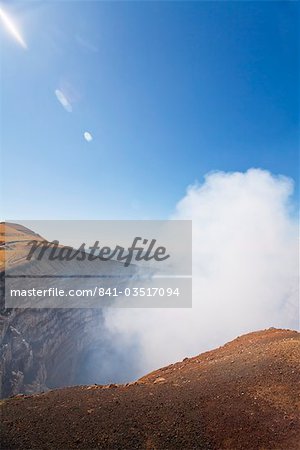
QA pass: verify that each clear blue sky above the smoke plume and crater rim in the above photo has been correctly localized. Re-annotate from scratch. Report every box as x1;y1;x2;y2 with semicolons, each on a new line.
0;1;299;220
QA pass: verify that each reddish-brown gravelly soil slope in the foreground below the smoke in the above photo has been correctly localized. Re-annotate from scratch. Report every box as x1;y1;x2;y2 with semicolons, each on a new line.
1;329;300;450
